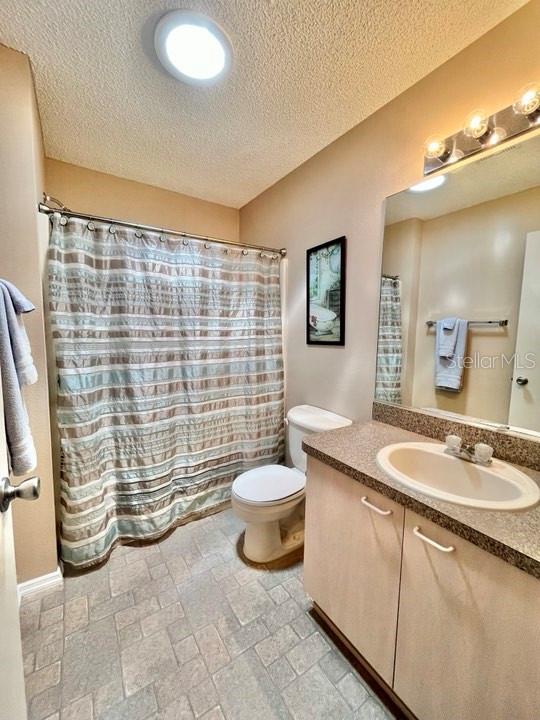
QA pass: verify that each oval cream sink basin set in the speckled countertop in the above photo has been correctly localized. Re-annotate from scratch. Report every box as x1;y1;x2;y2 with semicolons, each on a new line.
377;442;540;510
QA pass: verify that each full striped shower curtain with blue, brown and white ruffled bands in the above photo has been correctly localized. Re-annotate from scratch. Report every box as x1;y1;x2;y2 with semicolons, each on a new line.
49;215;284;567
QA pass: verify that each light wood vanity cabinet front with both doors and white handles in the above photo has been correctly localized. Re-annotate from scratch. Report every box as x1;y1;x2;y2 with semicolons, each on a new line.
304;457;540;720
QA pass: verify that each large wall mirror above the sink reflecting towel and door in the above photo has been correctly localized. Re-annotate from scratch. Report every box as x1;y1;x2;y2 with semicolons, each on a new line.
375;136;540;433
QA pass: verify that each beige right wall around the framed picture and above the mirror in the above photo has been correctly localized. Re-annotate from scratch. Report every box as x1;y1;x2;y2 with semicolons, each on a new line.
240;0;540;418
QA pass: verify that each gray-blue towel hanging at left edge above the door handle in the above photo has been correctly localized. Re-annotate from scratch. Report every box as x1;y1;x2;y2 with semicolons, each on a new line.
0;280;37;475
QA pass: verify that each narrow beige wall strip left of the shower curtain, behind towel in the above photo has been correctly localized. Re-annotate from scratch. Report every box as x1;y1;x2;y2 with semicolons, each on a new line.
0;46;57;581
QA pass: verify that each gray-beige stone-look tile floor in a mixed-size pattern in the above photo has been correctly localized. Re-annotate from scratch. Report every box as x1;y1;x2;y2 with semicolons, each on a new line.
21;510;390;720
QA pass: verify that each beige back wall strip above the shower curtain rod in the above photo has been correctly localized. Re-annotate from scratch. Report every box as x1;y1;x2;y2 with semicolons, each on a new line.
45;158;239;240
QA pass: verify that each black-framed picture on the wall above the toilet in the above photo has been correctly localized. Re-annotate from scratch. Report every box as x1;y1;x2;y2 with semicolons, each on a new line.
306;236;347;345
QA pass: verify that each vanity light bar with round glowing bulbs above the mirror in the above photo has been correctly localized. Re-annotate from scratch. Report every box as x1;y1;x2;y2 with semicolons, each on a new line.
424;82;540;175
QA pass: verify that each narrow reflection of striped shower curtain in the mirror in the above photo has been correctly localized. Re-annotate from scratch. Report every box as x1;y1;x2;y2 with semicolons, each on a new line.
375;276;402;403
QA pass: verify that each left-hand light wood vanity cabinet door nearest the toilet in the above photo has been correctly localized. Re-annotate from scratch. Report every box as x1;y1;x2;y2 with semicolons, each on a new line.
304;457;404;685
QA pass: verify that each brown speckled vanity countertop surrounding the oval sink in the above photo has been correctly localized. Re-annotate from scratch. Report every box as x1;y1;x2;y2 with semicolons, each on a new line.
303;420;540;579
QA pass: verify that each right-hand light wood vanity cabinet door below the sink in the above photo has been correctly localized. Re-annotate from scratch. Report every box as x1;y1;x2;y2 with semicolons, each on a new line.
394;510;540;720
